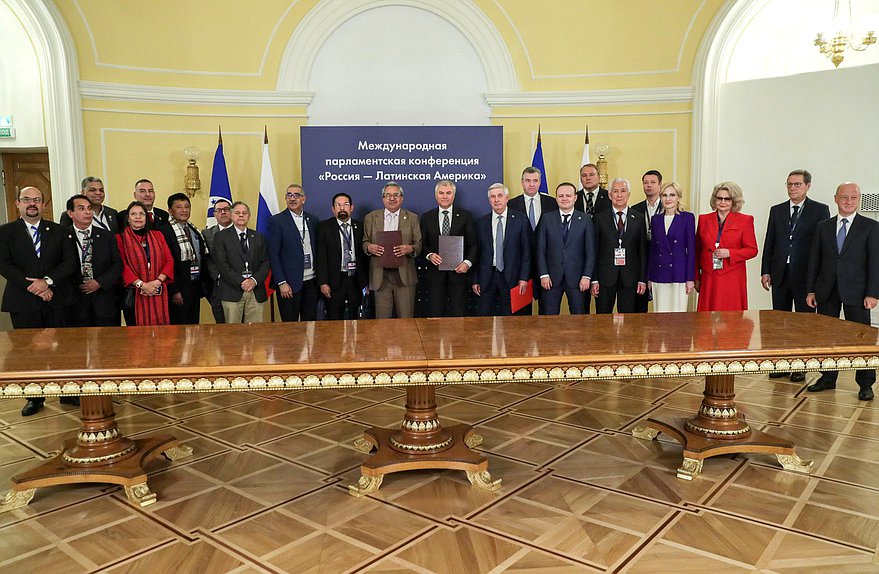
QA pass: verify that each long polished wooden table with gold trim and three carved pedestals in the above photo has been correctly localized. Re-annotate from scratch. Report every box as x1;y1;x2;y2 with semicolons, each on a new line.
0;311;879;511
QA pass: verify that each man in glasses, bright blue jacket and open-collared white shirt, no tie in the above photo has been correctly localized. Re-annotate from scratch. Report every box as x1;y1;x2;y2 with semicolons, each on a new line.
268;183;319;323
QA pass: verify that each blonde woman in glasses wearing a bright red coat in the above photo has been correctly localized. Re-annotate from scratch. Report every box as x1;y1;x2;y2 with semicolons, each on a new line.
696;181;757;311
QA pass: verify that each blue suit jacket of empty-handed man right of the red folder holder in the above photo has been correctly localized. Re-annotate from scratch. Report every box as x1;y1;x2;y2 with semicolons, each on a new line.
536;209;595;289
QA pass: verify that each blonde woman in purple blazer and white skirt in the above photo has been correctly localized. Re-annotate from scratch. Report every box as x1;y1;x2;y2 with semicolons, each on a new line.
647;182;696;313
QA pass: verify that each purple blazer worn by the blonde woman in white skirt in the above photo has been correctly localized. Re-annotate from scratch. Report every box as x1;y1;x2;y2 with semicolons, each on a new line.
647;211;696;283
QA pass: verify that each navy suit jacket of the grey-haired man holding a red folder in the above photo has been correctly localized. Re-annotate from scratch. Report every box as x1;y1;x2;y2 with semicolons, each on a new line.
473;209;531;289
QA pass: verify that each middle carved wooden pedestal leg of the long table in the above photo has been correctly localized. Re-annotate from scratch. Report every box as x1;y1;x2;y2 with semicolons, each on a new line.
348;385;501;497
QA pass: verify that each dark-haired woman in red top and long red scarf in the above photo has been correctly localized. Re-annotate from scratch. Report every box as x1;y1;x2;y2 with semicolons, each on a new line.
116;201;174;325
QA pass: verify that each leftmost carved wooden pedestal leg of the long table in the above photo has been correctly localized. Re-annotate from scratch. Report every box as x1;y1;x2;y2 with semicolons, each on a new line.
0;396;192;512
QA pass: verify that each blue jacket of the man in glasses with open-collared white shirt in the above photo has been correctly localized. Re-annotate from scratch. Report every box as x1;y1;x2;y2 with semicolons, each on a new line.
268;209;320;292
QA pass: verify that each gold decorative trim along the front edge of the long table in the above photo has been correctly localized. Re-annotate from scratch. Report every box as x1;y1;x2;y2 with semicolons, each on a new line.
2;355;879;398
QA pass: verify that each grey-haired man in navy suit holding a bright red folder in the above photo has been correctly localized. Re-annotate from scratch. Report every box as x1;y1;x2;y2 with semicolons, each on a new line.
472;183;531;316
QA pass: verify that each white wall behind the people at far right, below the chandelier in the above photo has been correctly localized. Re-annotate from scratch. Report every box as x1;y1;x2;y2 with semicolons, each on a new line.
716;64;879;309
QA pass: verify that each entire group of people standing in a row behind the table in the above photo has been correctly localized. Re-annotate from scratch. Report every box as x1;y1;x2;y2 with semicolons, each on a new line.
0;163;879;416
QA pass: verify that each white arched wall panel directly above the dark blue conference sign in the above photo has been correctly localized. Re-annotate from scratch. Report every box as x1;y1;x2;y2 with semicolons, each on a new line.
308;6;490;125
